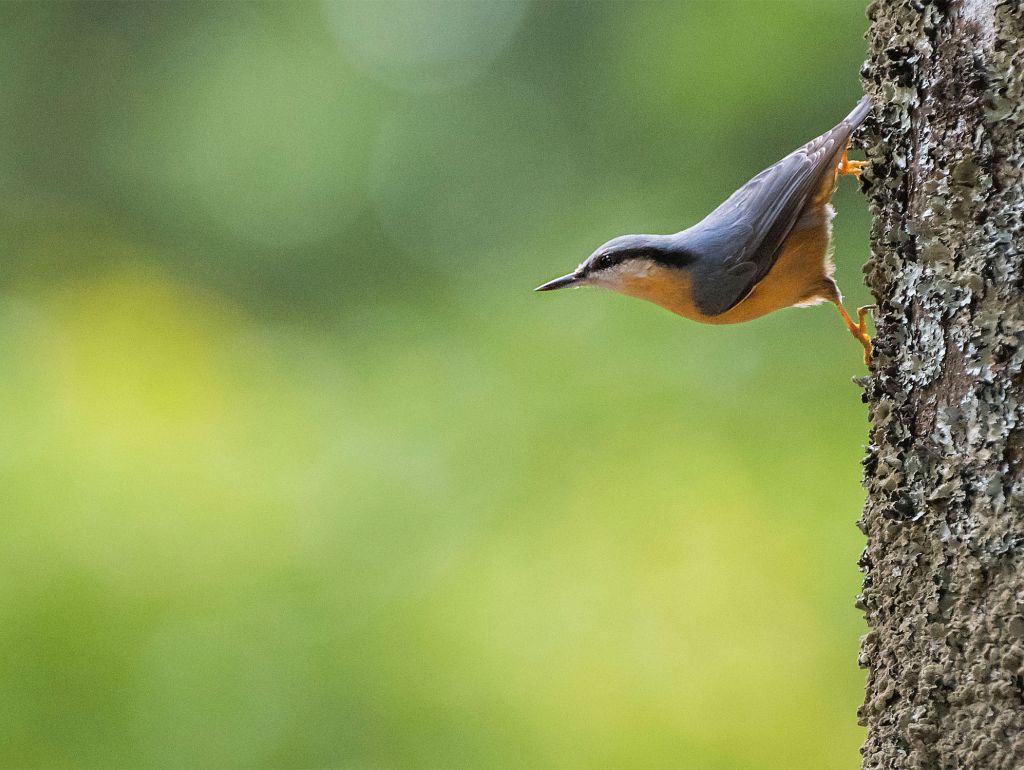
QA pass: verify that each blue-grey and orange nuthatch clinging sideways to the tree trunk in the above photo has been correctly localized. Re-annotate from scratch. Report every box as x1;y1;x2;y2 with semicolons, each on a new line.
536;96;871;363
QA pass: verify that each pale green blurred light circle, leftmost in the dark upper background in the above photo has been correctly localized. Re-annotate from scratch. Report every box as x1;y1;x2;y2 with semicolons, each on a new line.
110;20;373;250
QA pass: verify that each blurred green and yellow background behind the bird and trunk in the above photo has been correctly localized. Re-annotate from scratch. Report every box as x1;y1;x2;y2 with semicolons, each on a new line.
0;0;868;769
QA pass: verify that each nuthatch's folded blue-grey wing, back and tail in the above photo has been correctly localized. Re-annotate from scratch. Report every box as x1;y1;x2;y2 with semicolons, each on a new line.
680;96;870;315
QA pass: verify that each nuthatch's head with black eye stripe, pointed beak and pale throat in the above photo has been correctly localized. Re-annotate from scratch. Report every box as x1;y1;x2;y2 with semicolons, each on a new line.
534;236;686;301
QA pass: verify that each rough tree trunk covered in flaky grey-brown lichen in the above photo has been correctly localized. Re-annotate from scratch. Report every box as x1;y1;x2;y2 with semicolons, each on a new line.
860;0;1024;769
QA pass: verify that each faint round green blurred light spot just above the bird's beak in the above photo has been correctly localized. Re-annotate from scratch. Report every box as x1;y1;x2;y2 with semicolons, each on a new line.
371;84;577;270
